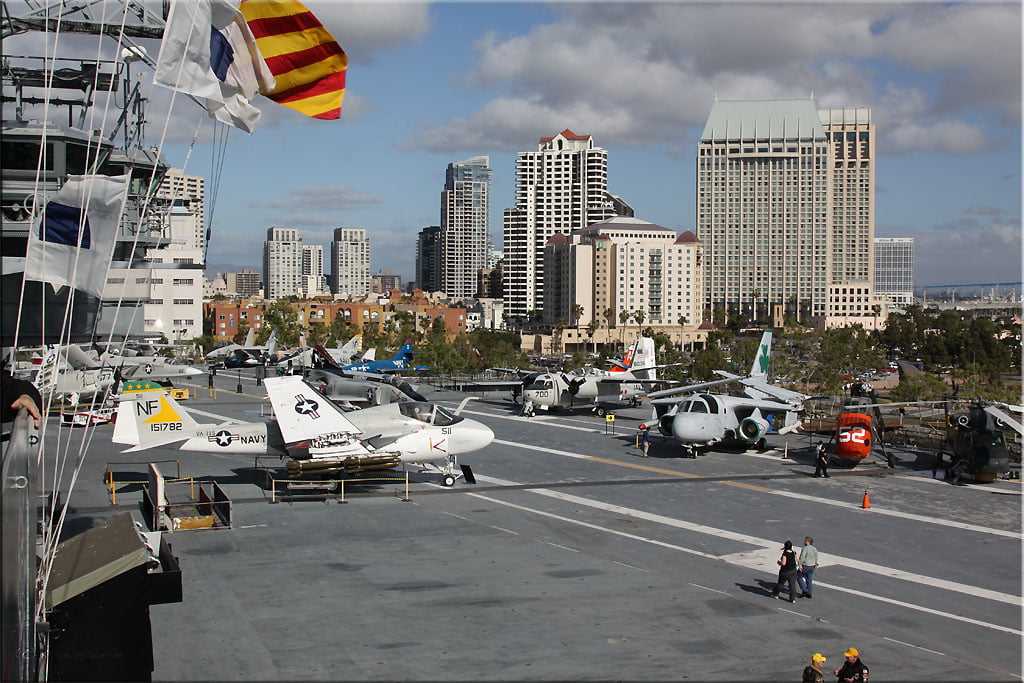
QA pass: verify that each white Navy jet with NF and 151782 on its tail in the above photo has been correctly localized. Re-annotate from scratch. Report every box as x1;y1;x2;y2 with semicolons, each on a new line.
113;375;495;486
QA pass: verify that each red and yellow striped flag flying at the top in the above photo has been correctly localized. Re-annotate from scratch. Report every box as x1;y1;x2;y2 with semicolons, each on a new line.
239;0;348;119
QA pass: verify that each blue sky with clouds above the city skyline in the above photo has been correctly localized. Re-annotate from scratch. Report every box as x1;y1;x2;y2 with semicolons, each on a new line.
5;1;1022;285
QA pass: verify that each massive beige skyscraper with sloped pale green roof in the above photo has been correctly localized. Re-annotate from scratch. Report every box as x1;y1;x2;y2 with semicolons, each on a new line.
696;99;874;318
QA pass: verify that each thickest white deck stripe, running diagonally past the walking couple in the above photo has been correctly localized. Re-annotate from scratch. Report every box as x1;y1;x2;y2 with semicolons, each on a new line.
476;475;1021;606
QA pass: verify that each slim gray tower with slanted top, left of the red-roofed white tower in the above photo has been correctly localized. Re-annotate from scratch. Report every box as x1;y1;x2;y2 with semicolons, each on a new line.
440;157;490;297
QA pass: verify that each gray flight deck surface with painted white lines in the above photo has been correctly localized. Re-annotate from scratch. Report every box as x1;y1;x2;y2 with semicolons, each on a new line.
51;373;1021;681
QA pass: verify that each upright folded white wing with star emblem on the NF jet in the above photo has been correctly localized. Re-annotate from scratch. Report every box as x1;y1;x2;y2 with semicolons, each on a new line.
263;375;361;446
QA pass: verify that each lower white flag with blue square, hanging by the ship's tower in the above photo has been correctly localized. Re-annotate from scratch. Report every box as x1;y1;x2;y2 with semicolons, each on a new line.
25;175;130;297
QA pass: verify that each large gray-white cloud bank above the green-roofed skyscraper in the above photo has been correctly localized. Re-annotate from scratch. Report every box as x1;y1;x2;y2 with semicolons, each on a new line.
403;2;1021;155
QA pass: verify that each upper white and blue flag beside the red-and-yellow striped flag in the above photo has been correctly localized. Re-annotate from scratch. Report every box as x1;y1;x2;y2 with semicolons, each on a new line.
153;0;275;133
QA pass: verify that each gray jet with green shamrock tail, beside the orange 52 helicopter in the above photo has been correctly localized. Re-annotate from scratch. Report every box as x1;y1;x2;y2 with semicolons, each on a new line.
641;330;809;458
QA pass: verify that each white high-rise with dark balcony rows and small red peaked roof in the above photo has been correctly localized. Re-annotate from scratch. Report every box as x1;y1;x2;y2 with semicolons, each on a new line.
503;129;615;321
